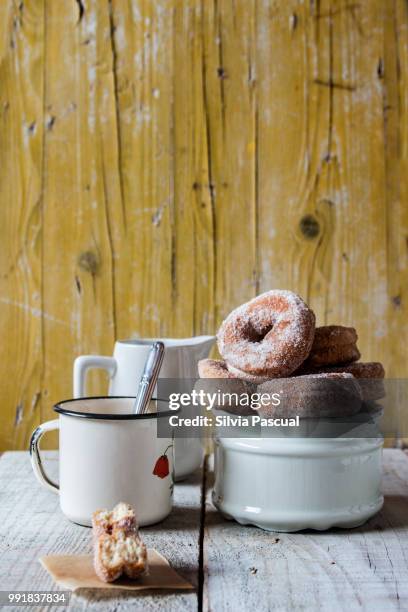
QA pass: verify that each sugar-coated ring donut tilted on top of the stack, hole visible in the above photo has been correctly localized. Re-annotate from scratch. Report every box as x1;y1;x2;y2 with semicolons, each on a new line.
217;290;315;378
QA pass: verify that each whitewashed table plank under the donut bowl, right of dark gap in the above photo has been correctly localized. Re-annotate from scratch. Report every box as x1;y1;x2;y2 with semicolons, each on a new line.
203;450;408;612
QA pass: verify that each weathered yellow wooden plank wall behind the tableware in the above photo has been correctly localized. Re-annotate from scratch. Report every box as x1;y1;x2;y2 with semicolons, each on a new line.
0;0;408;449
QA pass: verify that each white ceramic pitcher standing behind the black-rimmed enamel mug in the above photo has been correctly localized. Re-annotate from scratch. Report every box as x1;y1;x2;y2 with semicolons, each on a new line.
74;336;215;480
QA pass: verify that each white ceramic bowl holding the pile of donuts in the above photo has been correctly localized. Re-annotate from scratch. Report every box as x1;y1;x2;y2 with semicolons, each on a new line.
213;437;383;532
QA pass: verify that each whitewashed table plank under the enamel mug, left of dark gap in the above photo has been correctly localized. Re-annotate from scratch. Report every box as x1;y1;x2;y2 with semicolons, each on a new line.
0;451;201;612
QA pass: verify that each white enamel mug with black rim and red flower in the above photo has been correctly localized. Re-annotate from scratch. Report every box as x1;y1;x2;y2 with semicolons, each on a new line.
30;397;173;526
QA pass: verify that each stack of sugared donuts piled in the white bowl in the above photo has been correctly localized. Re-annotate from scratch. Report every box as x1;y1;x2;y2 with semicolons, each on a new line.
198;290;384;417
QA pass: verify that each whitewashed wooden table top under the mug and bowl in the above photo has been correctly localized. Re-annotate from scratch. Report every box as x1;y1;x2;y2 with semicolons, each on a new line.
0;450;408;612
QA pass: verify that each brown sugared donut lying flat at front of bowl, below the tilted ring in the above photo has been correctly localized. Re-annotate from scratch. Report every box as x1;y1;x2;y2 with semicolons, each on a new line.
257;372;362;418
